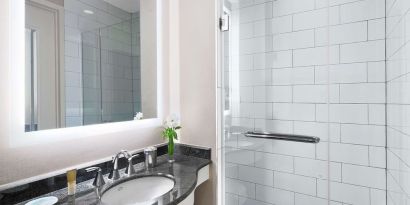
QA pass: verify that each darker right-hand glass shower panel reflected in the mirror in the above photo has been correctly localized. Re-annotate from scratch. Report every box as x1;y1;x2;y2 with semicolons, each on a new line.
100;20;134;122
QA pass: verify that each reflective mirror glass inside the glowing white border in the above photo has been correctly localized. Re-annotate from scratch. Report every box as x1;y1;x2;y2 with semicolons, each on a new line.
25;0;157;132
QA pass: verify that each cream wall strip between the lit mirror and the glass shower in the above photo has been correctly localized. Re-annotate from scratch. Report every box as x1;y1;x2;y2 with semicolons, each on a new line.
178;0;217;205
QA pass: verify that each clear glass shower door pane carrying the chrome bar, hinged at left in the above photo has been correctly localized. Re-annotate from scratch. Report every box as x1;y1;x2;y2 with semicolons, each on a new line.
221;0;332;205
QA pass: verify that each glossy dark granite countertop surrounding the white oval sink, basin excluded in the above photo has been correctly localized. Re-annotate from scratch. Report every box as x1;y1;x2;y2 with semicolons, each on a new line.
19;154;211;205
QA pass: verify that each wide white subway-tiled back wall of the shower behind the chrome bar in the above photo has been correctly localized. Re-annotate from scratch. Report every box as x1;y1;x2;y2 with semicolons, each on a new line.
224;0;386;205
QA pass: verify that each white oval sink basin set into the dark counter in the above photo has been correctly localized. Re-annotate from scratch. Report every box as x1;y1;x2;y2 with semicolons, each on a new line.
101;176;175;205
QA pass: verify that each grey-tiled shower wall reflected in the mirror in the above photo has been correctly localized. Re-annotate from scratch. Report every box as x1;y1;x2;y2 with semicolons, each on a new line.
64;0;141;127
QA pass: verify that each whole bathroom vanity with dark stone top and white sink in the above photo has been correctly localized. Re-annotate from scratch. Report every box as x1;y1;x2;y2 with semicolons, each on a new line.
0;144;211;205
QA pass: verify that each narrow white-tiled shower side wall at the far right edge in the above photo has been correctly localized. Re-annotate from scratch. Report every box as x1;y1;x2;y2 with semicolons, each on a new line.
386;0;410;205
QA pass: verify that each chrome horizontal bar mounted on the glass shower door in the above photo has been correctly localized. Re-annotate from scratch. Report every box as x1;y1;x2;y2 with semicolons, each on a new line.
244;131;320;144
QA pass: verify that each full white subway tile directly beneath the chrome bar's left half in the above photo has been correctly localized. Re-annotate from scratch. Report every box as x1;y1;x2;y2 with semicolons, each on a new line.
255;152;293;172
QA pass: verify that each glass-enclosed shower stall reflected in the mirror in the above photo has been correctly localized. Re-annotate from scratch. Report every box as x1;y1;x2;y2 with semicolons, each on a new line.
81;13;141;125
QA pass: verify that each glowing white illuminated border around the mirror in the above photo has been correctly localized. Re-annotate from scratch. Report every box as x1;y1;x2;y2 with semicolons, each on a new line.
8;0;163;147
